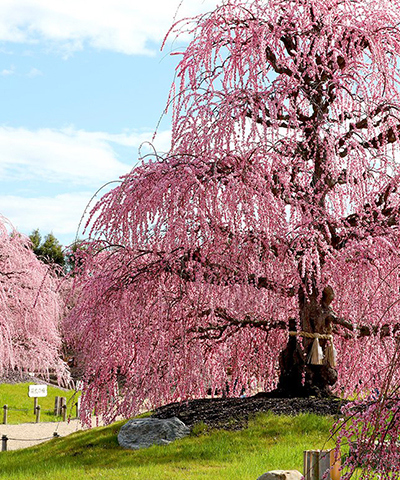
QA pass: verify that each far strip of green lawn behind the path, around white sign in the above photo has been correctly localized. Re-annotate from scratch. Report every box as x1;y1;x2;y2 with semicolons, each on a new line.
0;383;80;424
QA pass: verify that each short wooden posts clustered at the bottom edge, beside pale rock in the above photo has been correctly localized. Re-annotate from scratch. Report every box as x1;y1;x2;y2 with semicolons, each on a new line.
303;450;341;480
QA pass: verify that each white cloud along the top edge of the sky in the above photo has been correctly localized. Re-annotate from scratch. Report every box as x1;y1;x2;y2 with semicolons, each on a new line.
0;0;216;55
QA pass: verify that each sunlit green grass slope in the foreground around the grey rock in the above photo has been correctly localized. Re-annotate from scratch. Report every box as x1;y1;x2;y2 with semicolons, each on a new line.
0;414;340;480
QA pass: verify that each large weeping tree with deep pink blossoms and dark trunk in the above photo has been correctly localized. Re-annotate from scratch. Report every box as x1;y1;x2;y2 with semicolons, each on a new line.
67;0;400;418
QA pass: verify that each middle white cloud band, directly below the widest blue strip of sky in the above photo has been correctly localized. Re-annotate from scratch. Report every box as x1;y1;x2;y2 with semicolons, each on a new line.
0;126;170;188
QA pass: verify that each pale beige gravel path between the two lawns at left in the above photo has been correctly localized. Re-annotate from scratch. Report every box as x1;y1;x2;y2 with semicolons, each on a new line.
0;418;101;450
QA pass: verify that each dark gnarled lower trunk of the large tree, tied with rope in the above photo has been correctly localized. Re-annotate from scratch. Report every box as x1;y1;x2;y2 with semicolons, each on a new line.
277;286;337;397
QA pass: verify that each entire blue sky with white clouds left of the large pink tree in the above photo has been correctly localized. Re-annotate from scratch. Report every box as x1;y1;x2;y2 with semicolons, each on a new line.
0;0;216;245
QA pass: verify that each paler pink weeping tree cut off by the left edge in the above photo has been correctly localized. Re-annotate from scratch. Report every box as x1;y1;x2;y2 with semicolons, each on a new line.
0;218;63;376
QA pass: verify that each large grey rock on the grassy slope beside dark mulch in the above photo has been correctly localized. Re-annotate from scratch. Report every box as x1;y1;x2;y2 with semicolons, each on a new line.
118;417;190;450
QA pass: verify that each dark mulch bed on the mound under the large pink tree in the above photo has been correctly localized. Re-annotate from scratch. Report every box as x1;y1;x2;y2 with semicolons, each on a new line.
152;394;347;430
